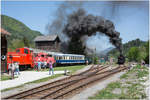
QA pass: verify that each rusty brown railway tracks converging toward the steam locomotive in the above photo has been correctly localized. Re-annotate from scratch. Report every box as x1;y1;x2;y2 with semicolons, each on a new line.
3;65;126;99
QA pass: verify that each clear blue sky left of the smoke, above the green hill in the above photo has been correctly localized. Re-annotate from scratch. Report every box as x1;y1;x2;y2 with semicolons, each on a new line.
2;1;60;34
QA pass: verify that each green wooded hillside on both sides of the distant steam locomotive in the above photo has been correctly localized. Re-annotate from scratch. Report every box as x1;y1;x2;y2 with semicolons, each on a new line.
107;39;149;61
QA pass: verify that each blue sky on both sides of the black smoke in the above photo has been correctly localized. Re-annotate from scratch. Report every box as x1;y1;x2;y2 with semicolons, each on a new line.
1;1;149;43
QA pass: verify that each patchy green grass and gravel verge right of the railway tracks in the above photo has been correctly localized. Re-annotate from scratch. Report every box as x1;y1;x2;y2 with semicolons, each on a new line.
89;65;149;99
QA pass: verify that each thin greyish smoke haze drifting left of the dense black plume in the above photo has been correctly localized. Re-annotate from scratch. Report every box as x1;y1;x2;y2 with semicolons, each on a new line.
46;1;84;53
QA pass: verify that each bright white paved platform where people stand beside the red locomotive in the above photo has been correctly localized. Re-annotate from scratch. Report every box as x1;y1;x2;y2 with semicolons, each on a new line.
0;71;64;90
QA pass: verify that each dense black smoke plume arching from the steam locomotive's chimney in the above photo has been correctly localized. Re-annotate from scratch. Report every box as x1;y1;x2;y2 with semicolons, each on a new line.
63;9;122;54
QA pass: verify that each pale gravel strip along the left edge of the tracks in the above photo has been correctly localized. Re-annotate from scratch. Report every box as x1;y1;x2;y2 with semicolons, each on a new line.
1;65;91;98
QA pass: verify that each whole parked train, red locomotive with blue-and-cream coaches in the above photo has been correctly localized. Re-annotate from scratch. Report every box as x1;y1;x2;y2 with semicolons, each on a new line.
7;47;85;69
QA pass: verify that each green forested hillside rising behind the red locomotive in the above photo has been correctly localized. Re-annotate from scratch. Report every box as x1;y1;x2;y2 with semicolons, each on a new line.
1;15;42;51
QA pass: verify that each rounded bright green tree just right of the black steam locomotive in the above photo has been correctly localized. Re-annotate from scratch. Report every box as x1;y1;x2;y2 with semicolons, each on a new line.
127;47;141;61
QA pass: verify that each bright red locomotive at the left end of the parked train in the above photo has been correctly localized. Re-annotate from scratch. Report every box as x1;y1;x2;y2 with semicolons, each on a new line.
7;48;55;69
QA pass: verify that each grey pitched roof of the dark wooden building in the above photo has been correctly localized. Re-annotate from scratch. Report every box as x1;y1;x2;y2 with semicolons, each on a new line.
34;35;60;42
